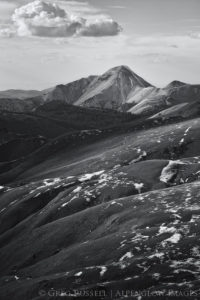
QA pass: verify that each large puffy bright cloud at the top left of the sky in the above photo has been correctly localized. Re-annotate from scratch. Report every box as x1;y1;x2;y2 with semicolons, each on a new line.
0;0;121;37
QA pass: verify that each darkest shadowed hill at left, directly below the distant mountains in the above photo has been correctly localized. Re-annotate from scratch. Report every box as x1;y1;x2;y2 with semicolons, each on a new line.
0;100;136;169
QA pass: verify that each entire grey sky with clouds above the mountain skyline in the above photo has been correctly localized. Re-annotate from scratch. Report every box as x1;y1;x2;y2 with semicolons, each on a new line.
0;0;200;90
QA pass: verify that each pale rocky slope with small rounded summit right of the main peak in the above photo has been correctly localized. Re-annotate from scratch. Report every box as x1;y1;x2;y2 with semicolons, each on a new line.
129;81;200;118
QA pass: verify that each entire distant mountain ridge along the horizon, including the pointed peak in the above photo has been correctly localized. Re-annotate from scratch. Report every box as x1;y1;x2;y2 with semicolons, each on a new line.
0;65;200;117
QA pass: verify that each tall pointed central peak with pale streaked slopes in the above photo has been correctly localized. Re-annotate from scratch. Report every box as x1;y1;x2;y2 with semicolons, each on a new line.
75;66;151;110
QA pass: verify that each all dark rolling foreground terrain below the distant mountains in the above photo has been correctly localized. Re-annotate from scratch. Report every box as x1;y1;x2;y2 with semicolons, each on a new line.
0;67;200;300
